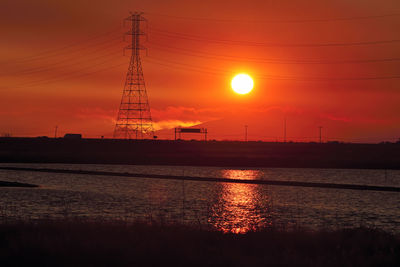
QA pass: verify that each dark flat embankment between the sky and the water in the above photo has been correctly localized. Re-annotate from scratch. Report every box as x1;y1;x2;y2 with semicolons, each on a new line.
0;138;400;169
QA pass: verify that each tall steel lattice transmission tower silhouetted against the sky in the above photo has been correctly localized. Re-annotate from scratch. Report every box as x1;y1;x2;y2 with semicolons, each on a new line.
114;12;154;139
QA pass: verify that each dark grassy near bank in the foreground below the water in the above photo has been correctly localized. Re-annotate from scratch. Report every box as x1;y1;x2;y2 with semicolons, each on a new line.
0;221;400;266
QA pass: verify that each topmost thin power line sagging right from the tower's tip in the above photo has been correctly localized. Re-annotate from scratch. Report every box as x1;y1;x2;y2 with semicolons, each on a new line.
146;13;400;23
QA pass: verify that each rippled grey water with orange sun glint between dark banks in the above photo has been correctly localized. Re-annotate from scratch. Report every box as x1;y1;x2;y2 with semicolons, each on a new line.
0;164;400;233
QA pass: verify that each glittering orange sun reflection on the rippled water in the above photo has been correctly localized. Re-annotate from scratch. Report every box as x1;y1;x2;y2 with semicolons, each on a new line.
212;170;270;233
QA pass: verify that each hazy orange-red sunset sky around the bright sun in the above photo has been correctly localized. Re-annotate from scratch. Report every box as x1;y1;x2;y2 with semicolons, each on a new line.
0;0;400;142
